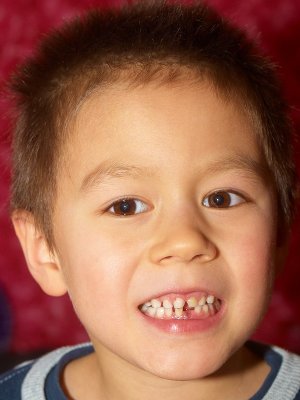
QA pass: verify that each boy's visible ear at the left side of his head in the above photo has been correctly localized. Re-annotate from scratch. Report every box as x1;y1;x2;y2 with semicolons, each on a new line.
12;210;67;296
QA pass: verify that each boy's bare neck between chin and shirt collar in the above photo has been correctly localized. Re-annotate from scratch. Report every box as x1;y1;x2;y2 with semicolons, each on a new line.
64;347;269;400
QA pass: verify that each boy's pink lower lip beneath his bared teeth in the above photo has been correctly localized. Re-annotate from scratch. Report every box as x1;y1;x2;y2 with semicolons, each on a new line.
139;306;224;335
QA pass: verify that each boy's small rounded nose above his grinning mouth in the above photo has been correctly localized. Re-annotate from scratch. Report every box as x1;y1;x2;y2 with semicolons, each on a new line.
150;219;217;265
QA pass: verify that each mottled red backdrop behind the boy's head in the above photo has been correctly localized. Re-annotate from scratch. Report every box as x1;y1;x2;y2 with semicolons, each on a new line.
0;0;300;352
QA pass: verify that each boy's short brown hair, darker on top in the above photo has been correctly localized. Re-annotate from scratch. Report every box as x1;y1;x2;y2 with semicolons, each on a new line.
11;1;296;247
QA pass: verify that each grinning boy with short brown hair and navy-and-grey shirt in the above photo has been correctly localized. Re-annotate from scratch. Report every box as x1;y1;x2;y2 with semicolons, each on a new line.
0;2;300;400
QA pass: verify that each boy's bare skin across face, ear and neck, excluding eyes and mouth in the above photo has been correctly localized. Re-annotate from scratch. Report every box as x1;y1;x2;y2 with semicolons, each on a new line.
13;81;282;400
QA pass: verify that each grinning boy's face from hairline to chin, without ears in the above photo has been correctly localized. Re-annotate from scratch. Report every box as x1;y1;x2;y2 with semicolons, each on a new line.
53;82;277;380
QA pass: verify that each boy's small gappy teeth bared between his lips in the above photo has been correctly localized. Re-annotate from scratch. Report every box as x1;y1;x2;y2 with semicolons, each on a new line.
139;294;222;320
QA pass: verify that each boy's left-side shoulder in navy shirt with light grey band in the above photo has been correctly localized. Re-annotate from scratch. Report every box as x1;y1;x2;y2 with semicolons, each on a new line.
0;343;93;400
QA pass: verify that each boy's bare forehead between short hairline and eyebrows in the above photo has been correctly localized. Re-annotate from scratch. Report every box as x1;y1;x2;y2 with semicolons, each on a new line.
59;80;263;192
